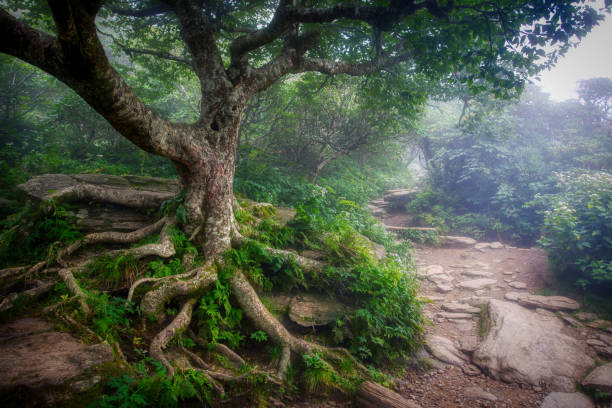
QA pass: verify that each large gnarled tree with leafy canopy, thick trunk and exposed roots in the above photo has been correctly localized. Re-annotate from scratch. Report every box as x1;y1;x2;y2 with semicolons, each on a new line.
0;0;602;386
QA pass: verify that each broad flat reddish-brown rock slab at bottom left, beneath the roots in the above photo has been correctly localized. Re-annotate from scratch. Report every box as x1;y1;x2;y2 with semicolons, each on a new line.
0;319;113;392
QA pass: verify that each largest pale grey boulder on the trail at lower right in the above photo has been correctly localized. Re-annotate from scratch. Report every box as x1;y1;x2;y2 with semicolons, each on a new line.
472;299;594;391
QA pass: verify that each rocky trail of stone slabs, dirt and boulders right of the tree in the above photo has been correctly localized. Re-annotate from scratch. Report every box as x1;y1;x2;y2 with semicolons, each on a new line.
370;190;612;408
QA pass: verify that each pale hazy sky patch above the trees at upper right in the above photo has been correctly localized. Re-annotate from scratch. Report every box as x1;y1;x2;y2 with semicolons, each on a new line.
535;6;612;101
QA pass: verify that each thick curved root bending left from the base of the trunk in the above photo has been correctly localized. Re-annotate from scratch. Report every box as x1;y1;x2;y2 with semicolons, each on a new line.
140;265;217;320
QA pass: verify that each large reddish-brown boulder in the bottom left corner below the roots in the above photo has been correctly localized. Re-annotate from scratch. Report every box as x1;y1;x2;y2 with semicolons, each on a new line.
0;319;113;406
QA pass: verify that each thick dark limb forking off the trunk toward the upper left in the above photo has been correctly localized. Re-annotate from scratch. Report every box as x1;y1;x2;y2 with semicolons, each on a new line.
0;5;185;161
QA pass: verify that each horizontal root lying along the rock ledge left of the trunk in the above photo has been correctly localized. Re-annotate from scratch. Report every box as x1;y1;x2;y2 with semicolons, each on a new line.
49;184;176;208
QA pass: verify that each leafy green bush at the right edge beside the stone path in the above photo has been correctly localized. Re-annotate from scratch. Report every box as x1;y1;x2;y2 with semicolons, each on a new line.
539;171;612;294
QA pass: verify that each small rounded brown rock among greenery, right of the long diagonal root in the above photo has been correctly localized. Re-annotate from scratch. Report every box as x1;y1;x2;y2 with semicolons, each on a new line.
289;293;346;327
